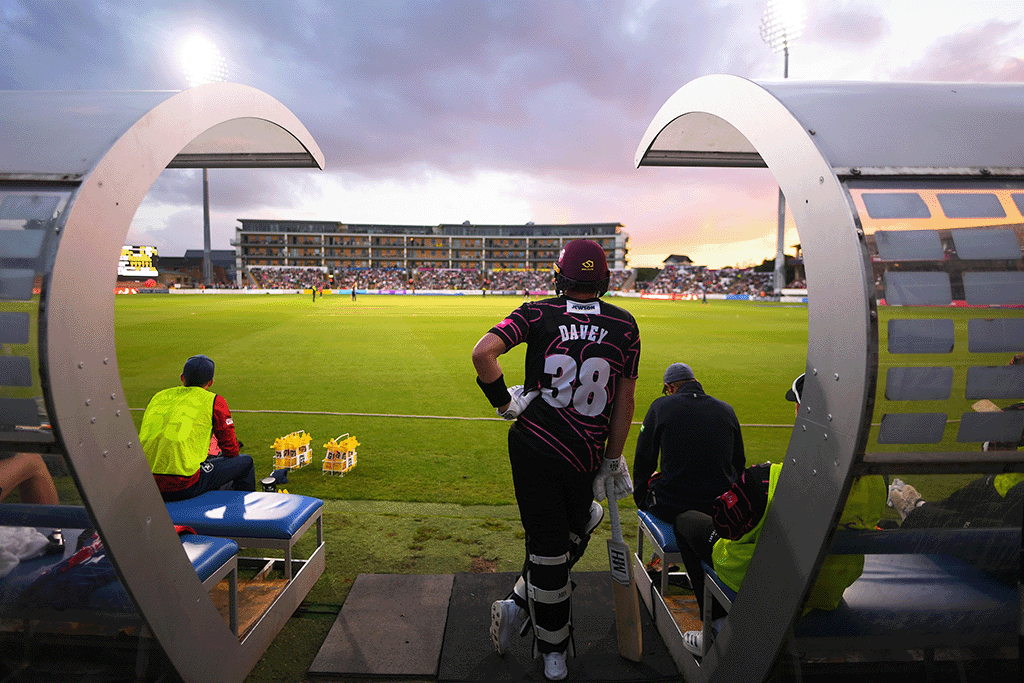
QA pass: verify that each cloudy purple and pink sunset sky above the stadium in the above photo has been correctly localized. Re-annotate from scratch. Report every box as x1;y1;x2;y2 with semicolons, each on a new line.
0;0;1024;267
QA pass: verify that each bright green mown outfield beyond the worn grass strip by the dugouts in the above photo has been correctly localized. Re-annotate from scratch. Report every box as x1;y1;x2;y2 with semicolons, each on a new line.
116;295;807;505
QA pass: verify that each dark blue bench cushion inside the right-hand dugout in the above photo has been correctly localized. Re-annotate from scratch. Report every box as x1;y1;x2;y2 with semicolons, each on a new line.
795;555;1020;640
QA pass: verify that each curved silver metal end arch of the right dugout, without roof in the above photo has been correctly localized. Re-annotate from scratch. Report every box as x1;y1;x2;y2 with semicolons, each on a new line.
636;76;878;680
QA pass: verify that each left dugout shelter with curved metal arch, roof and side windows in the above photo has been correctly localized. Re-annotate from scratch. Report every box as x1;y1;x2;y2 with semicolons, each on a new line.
0;83;324;681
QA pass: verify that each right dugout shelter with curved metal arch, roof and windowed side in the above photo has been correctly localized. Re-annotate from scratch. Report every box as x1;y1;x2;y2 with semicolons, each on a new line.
635;75;1024;682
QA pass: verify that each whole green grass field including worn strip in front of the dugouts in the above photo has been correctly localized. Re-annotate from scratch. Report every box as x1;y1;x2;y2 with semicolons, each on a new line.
108;295;1019;683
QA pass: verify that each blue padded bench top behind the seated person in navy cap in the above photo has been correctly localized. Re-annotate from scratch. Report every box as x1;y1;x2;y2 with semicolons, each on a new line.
167;490;324;540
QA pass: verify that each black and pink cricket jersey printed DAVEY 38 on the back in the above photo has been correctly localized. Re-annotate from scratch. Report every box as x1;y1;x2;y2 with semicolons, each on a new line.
490;296;640;472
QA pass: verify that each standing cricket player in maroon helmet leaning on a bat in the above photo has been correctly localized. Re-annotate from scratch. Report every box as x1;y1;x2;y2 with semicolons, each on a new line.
473;240;640;681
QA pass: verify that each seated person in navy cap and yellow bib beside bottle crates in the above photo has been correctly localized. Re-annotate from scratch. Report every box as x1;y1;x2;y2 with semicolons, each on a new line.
139;354;256;501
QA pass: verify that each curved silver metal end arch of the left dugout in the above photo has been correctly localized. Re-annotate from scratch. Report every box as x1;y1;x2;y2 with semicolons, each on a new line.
40;83;323;681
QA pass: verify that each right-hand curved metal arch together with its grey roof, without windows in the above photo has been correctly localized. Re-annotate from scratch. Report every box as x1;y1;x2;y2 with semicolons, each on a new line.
635;75;1024;681
